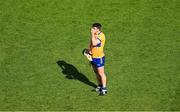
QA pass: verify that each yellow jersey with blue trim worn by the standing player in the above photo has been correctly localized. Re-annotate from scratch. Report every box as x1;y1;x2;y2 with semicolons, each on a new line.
91;32;106;58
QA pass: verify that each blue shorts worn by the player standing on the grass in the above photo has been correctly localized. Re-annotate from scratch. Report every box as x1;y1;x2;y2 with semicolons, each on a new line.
91;56;105;68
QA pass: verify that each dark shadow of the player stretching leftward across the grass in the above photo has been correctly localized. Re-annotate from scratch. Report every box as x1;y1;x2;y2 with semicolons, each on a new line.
56;61;96;88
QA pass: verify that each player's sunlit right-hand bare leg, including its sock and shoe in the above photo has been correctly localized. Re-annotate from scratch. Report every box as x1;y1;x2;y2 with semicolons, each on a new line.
97;66;107;95
